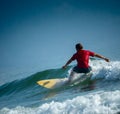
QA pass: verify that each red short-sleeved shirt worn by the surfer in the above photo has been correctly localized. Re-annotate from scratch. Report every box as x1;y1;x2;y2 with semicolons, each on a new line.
71;50;95;68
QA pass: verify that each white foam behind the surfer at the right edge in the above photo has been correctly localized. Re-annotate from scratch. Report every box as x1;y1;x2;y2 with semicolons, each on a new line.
91;61;120;80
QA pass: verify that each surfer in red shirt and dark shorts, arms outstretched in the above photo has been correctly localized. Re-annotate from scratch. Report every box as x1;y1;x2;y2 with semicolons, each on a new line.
62;43;109;82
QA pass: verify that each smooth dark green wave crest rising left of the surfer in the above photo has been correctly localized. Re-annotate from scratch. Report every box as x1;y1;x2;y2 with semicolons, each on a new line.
0;69;67;97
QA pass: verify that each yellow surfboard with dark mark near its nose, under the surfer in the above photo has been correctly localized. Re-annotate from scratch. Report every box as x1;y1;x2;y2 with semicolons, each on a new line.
37;73;92;89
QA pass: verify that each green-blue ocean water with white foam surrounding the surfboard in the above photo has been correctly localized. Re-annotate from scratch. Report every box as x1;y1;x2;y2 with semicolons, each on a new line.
0;60;120;114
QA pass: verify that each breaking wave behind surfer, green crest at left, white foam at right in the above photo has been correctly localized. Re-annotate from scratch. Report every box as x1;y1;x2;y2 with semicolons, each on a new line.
0;60;120;97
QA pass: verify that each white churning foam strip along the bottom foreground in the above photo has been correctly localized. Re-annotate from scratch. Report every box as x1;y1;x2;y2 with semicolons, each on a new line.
0;90;120;114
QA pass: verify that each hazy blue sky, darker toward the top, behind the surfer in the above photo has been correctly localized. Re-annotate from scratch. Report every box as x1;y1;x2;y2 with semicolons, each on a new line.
0;0;120;69
